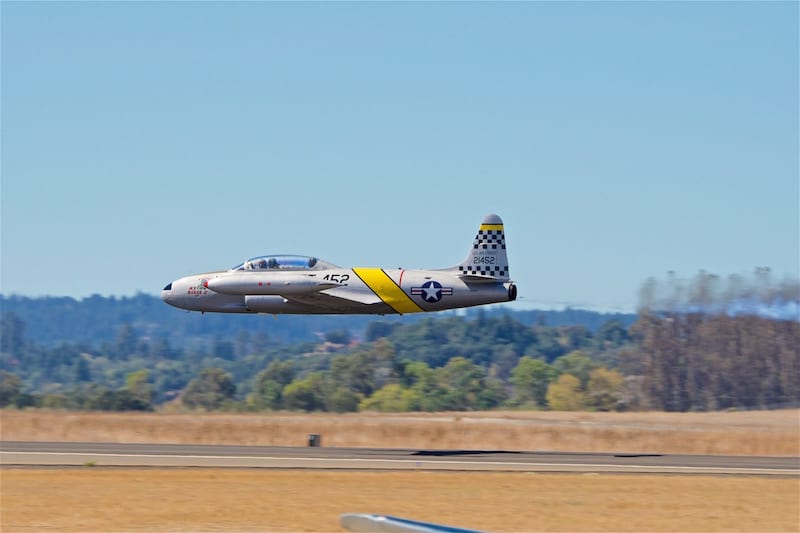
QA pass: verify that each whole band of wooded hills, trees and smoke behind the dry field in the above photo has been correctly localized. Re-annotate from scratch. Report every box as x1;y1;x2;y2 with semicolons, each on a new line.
0;273;800;412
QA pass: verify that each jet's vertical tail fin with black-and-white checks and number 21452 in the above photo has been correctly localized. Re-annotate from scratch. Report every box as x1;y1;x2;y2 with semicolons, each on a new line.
457;215;509;281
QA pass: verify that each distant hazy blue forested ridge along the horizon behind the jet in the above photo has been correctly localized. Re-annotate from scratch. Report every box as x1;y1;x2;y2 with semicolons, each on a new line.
0;294;636;348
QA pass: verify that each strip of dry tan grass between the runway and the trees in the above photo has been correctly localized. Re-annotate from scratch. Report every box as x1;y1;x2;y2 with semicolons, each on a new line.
0;409;800;456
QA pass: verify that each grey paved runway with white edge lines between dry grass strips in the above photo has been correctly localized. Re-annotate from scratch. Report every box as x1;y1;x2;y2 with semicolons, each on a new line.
0;441;800;477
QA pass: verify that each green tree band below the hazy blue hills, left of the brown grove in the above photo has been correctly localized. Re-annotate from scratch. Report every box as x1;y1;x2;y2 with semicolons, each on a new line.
0;312;627;411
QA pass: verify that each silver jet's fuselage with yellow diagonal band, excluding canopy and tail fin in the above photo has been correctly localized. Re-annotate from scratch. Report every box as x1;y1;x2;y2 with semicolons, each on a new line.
162;268;516;314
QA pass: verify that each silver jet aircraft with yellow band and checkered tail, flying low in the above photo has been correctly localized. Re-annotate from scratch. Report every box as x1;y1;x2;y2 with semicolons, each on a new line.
161;215;517;315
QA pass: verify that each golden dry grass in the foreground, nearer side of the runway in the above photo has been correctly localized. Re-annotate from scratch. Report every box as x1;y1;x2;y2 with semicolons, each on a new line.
0;467;800;533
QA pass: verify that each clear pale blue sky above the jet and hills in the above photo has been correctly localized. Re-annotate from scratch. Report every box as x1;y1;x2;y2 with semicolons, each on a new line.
0;1;800;309
